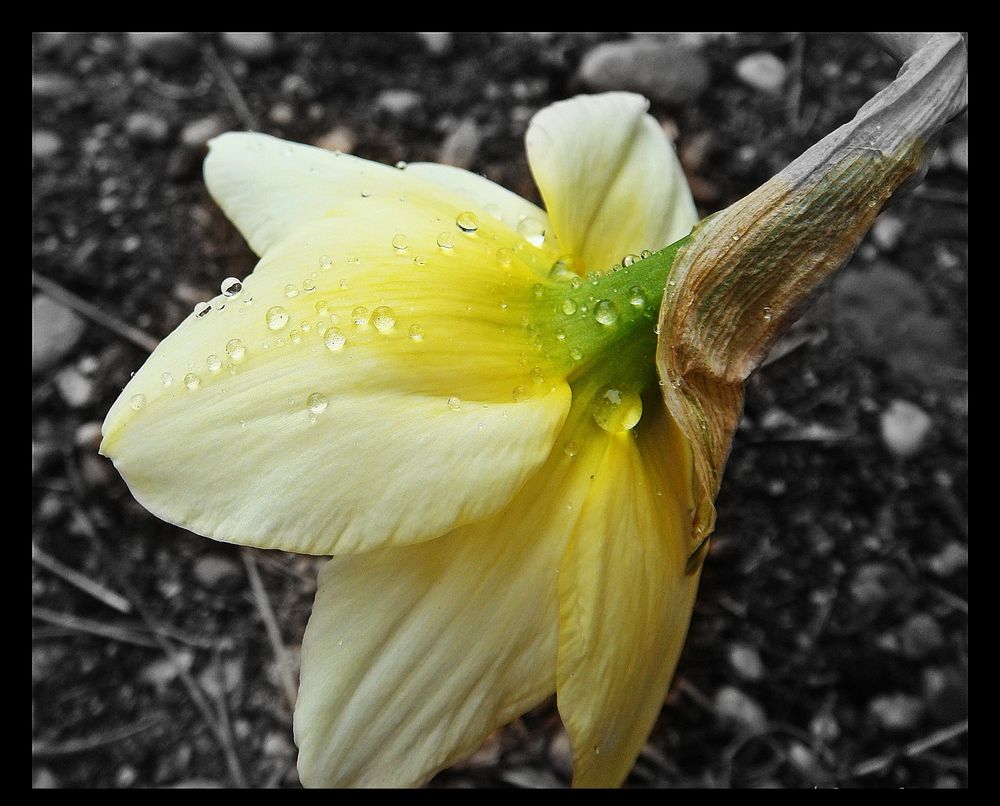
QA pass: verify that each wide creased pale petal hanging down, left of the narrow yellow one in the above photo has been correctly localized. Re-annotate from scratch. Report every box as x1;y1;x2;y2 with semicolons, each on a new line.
295;400;603;786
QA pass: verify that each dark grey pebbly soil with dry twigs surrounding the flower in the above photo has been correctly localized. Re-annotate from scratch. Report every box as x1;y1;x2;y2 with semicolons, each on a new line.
31;32;968;788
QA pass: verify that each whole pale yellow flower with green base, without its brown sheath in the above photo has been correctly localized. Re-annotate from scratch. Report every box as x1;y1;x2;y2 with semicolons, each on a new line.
102;93;698;786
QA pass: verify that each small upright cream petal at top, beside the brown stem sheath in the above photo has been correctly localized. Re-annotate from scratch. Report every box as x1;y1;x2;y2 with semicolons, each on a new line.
525;92;698;271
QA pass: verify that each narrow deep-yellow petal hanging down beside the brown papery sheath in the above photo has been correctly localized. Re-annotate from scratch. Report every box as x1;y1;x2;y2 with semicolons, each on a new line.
558;389;698;786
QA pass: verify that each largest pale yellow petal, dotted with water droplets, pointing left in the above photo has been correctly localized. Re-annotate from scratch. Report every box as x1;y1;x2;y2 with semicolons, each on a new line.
102;158;569;554
